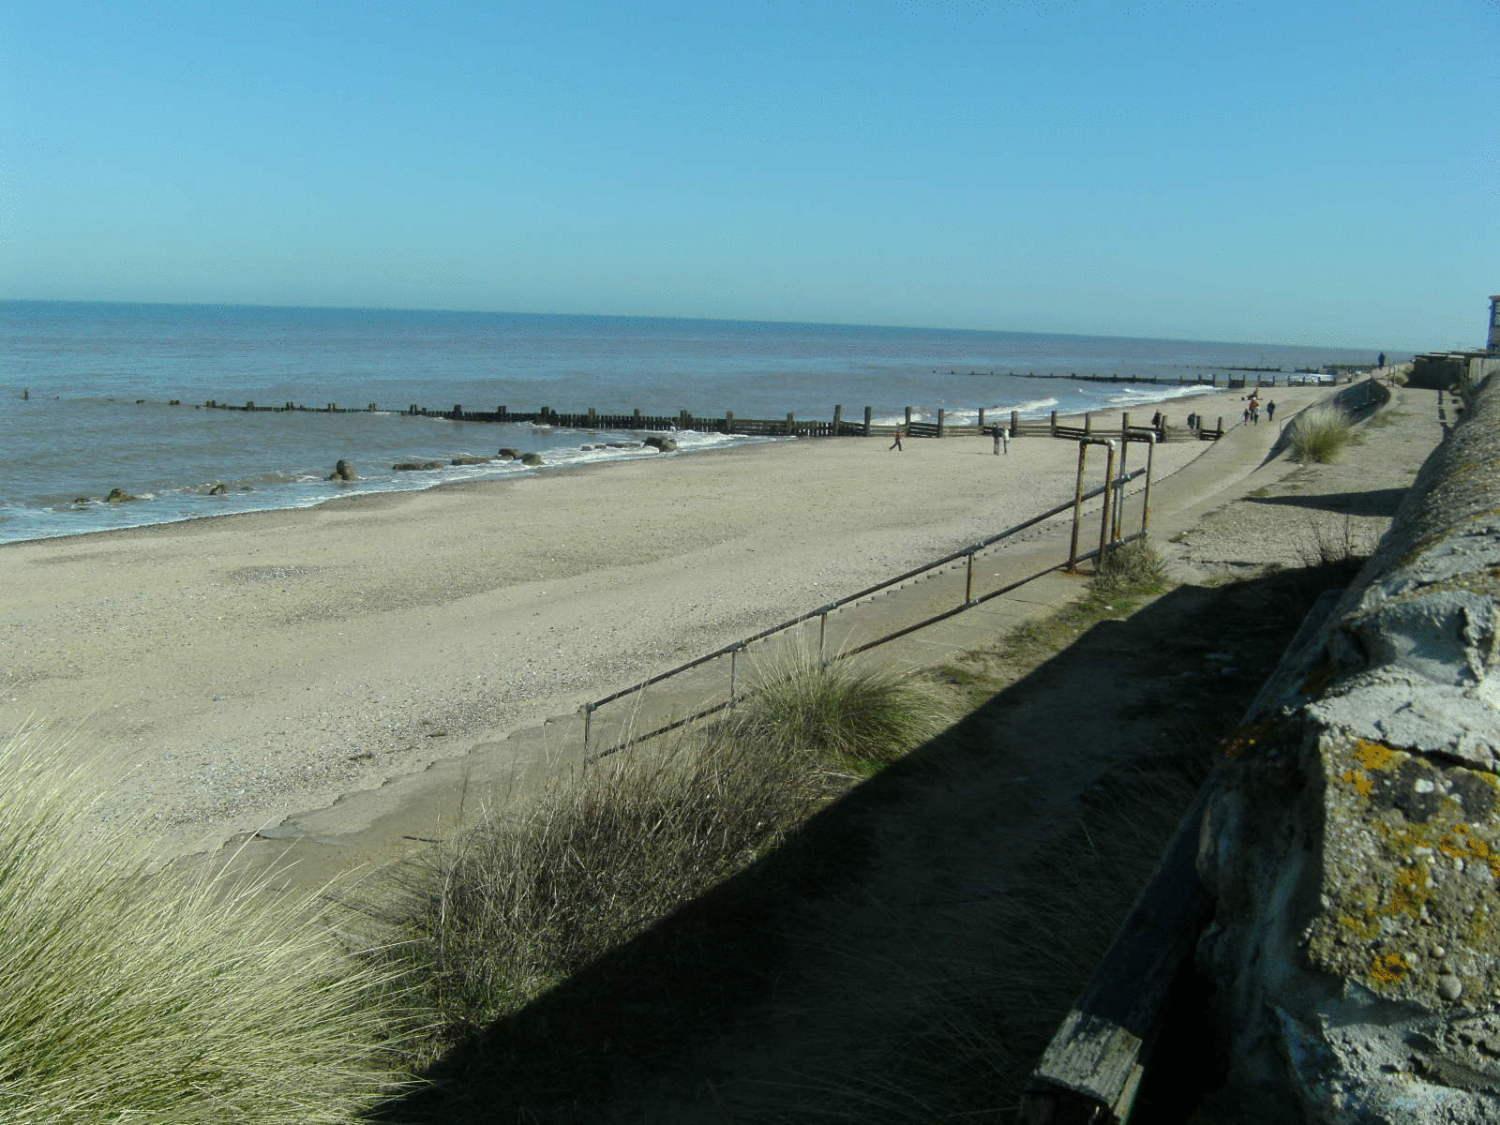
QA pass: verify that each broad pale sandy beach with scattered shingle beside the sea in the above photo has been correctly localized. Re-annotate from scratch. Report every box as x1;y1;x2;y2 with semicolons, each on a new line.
0;389;1320;851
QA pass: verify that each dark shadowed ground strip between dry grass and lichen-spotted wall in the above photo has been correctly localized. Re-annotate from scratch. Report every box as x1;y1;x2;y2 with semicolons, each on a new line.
360;543;1362;1122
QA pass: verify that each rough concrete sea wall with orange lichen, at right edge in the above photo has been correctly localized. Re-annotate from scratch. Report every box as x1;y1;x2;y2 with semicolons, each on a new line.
1197;377;1500;1125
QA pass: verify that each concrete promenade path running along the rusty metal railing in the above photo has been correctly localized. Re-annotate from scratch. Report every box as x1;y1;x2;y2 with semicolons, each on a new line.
219;379;1380;887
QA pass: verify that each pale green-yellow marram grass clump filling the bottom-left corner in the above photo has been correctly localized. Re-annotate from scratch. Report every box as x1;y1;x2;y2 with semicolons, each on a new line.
0;738;398;1125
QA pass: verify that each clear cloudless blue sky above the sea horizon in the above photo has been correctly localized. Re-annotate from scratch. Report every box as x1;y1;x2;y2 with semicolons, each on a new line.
0;0;1500;350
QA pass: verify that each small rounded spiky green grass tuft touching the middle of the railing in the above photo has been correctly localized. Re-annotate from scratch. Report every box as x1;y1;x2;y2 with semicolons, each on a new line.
725;648;950;767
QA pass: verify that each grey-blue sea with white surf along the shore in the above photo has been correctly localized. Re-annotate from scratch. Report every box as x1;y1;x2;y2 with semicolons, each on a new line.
0;302;1373;543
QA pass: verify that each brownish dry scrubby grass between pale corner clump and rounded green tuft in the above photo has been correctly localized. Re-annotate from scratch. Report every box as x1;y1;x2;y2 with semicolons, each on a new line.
372;732;819;1041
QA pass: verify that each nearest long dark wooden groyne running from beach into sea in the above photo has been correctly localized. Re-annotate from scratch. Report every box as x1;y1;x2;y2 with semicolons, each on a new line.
196;399;1224;441
